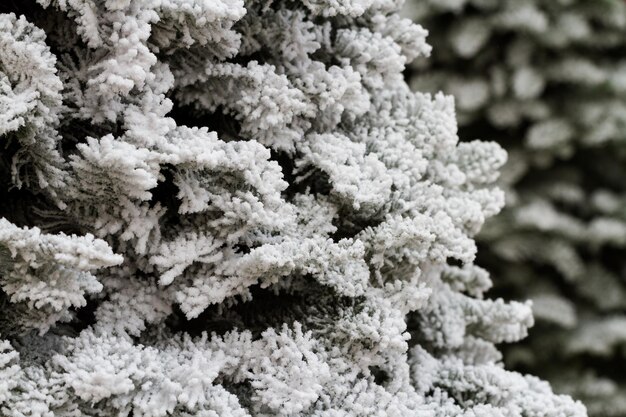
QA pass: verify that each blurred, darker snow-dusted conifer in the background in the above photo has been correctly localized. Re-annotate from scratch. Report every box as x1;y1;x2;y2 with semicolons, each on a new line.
405;0;626;417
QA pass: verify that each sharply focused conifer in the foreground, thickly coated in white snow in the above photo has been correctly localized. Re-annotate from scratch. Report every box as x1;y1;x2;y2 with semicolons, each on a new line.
0;0;585;417
